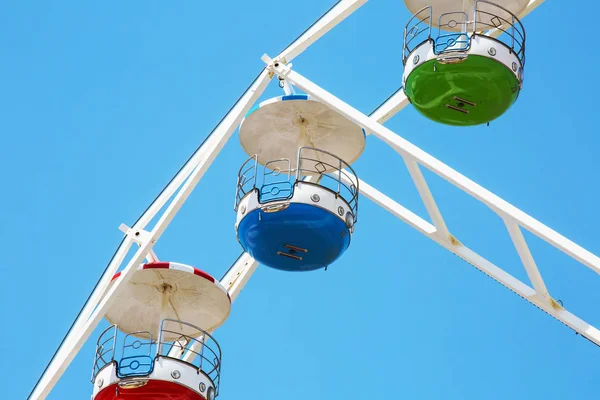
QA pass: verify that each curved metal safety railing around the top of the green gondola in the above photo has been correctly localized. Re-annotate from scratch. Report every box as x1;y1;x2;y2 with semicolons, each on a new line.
402;0;525;65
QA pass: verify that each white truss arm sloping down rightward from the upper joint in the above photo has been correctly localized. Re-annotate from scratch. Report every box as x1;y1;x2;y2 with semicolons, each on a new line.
270;60;600;345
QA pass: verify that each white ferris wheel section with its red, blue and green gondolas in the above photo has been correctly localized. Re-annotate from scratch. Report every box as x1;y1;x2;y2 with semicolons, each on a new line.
29;0;600;400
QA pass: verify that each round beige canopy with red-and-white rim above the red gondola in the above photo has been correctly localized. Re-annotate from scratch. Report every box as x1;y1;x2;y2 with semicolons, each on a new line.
105;263;231;341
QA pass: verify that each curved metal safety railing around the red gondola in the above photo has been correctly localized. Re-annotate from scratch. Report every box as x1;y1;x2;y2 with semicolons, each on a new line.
91;319;221;395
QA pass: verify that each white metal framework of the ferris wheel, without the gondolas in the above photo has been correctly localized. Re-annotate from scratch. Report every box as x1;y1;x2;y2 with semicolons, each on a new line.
30;0;600;400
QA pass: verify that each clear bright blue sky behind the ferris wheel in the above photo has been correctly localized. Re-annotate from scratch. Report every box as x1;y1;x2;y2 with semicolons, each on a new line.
0;0;600;400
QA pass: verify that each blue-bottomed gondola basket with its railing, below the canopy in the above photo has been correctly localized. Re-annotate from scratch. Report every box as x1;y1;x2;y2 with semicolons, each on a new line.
235;147;358;271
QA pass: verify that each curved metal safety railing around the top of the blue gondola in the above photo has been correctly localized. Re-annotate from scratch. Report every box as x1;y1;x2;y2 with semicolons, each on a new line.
234;147;359;222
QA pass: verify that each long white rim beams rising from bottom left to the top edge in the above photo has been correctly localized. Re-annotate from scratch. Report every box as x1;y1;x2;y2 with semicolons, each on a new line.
30;0;366;400
